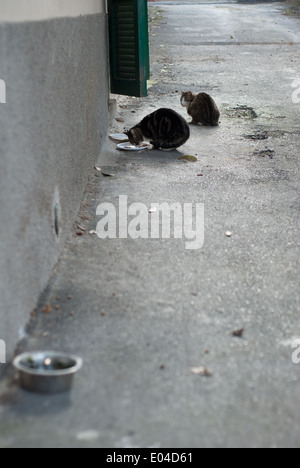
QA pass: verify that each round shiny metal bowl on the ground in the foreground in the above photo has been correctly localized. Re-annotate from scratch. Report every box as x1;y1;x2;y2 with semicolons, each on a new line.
13;351;82;393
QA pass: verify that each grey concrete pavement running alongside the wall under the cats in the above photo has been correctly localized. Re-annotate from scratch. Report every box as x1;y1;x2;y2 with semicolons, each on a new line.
0;0;300;448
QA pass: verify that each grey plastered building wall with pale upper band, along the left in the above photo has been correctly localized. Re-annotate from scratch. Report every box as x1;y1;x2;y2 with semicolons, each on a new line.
0;0;109;372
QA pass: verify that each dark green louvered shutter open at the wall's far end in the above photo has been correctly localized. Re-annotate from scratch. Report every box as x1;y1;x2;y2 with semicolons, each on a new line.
108;0;150;96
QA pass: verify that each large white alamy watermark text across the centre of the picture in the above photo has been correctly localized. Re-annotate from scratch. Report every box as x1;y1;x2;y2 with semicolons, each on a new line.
96;195;204;250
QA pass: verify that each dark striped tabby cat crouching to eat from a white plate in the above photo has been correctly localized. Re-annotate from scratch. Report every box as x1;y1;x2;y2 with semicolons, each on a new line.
125;108;190;151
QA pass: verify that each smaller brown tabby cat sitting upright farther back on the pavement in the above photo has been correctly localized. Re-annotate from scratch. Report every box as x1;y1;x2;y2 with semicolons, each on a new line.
180;91;221;127
